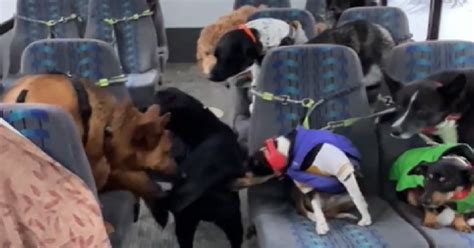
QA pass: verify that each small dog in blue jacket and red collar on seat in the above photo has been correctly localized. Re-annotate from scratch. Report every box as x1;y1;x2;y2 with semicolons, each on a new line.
246;127;372;235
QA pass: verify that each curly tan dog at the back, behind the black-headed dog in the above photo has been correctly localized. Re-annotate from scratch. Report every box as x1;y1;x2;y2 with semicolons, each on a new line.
196;5;266;75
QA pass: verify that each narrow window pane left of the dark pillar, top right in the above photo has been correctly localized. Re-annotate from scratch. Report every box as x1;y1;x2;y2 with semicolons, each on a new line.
387;0;430;41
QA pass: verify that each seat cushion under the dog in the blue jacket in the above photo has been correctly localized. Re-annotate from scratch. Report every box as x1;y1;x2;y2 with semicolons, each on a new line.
249;181;429;248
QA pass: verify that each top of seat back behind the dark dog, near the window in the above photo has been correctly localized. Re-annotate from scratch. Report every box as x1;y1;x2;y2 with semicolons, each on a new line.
337;6;412;44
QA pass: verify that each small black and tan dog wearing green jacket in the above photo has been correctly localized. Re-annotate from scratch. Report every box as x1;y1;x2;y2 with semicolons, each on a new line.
390;144;474;232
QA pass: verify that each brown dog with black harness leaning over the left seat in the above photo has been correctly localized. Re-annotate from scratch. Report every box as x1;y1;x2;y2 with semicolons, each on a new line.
3;74;178;232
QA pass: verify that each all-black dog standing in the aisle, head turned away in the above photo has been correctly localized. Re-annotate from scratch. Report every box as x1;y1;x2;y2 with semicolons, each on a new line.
155;88;247;248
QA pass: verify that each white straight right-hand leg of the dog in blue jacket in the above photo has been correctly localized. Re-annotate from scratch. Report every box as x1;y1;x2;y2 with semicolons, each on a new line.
341;173;372;226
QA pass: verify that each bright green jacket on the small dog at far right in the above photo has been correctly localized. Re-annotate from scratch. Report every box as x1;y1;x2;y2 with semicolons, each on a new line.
389;144;474;213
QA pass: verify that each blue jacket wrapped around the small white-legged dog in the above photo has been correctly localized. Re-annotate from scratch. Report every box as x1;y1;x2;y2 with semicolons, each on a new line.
287;127;361;194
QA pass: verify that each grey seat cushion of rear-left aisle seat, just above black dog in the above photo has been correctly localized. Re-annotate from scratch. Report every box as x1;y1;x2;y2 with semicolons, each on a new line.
126;69;160;107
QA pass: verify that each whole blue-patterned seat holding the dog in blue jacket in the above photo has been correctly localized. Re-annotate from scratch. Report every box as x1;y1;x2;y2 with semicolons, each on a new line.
249;45;428;248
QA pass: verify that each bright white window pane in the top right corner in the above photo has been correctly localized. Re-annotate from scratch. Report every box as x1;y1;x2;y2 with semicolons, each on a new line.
439;0;474;41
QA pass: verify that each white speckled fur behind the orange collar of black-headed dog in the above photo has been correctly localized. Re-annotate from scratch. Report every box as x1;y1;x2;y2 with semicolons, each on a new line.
244;18;294;53
